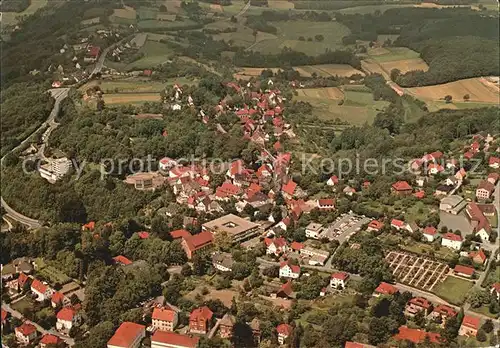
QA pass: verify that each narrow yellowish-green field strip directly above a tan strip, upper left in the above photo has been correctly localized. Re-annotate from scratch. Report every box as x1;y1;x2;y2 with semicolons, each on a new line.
80;79;165;93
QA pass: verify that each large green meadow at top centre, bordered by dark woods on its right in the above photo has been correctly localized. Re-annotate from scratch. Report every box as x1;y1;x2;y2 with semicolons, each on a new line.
251;20;350;56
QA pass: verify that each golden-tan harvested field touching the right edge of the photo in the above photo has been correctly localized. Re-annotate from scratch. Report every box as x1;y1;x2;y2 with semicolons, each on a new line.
406;77;499;104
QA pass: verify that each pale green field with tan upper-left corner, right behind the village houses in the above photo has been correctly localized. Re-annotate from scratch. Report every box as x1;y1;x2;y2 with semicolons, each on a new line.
294;87;389;125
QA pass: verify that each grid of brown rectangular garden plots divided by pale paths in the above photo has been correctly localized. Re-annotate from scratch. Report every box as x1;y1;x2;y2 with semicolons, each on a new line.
385;251;450;291
